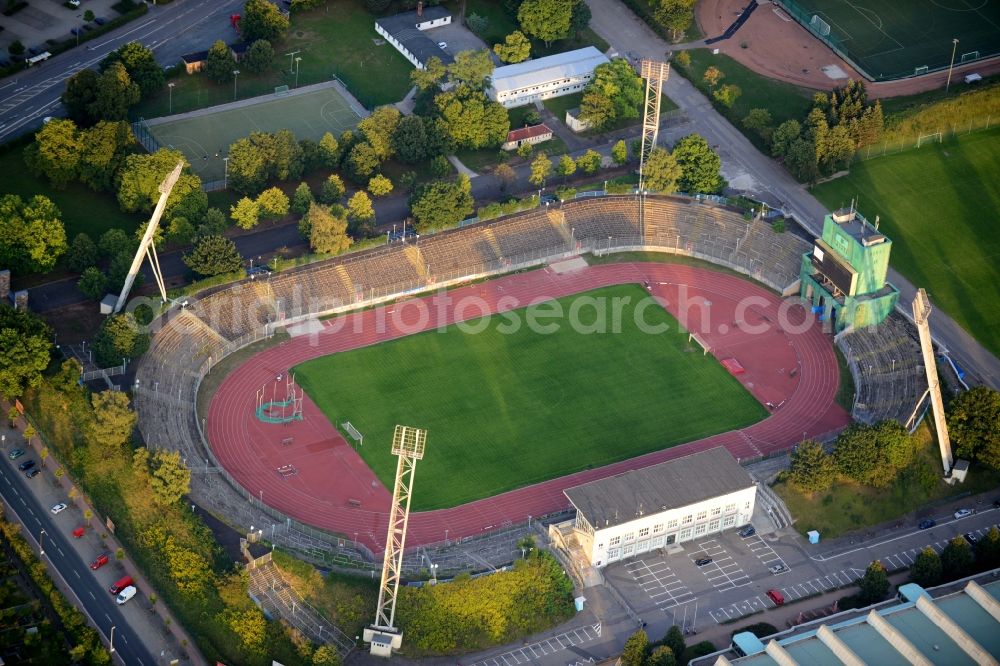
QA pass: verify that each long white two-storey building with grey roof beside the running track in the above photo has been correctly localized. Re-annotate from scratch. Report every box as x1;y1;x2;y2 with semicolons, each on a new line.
563;446;757;568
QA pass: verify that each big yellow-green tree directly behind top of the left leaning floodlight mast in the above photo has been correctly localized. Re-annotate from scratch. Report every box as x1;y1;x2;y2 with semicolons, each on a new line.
116;148;205;220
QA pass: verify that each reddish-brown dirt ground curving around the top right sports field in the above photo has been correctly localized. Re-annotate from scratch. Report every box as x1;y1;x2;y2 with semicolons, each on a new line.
696;0;1000;98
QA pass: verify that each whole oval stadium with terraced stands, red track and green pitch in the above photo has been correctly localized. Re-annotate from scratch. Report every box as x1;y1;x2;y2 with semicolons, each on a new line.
136;195;922;570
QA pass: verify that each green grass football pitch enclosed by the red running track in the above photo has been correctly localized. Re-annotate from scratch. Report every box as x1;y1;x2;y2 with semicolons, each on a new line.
295;285;766;511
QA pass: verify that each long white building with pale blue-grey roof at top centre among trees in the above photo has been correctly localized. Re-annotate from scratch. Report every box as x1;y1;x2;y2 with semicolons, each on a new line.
486;46;610;109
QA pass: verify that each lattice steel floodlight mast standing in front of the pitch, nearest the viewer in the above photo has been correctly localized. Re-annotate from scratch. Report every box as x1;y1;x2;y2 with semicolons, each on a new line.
365;425;427;657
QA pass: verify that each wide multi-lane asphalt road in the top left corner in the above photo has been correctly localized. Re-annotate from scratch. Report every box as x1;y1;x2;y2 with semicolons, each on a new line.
0;0;243;141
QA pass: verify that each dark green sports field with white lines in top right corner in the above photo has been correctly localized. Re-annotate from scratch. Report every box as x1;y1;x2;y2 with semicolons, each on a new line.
779;0;1000;81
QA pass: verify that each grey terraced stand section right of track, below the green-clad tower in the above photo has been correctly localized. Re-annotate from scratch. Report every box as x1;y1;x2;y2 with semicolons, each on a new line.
838;312;927;424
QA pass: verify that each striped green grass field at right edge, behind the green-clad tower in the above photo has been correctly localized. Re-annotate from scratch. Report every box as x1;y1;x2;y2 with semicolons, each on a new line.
813;129;1000;356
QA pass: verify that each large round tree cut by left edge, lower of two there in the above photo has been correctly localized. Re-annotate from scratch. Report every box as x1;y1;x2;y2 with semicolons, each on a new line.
0;303;52;400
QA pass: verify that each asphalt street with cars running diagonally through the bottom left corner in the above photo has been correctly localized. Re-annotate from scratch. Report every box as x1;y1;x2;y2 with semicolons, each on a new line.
0;454;156;666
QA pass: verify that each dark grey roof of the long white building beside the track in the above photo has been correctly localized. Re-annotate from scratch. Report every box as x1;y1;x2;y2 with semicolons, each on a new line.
563;446;753;530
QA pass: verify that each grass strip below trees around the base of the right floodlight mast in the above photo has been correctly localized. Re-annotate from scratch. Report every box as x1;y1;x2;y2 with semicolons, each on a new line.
774;421;1000;539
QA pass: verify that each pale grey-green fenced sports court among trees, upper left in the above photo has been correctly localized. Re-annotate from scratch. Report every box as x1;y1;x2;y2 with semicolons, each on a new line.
146;87;359;182
